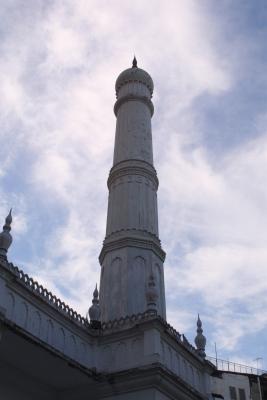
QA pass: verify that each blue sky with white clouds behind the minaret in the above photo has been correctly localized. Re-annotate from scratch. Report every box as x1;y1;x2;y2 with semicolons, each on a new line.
0;0;267;370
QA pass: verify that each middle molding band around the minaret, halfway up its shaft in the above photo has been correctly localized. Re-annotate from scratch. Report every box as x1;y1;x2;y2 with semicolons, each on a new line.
107;160;159;190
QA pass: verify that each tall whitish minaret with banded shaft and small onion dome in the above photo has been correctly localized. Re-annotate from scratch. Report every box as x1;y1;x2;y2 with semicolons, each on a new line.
99;58;166;322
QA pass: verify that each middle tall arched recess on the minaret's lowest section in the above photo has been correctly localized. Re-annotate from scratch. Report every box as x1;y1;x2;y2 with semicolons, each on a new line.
128;256;147;314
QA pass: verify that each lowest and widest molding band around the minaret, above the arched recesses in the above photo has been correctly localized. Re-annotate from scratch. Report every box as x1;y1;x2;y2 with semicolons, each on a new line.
99;230;166;265
